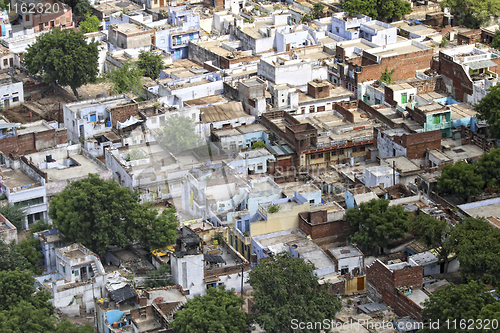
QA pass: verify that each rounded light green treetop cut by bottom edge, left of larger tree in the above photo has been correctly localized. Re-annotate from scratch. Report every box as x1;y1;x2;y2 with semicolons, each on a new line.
173;286;249;333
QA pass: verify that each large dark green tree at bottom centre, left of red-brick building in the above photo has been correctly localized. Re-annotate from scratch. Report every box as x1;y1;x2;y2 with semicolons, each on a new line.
248;253;341;333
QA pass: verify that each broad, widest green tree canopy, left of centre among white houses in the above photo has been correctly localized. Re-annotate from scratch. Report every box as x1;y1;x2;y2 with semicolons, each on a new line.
49;174;177;254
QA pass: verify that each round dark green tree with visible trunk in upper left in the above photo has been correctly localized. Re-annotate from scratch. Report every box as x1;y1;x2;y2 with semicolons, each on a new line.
24;29;99;98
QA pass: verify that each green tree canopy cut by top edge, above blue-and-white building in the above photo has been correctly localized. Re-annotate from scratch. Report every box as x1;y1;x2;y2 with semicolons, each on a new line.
342;0;411;21
